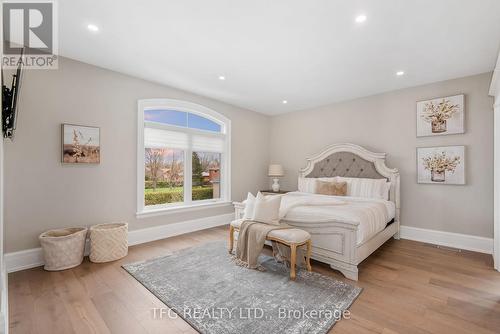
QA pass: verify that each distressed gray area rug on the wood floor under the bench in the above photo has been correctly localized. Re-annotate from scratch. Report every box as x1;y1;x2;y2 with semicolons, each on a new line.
123;242;361;334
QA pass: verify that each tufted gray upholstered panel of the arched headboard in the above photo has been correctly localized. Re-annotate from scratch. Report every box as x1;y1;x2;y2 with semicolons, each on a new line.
305;152;387;179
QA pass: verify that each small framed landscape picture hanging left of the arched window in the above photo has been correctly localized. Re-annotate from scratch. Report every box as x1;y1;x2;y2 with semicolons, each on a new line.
61;123;101;164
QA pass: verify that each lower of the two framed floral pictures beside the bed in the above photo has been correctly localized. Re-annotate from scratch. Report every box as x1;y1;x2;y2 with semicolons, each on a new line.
417;146;465;184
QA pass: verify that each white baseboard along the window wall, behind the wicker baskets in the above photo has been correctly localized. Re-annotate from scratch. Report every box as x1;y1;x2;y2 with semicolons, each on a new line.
5;213;234;273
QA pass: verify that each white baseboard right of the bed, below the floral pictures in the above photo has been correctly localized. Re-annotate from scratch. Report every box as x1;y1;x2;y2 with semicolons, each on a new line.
400;226;493;254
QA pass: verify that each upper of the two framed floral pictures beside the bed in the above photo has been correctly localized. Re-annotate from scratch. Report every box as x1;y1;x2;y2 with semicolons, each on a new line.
417;94;464;137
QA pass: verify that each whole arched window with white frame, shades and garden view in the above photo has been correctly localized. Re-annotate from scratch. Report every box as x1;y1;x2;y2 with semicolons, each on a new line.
137;99;231;215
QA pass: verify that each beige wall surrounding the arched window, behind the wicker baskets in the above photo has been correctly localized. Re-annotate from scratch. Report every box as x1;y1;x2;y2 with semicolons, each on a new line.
5;58;269;252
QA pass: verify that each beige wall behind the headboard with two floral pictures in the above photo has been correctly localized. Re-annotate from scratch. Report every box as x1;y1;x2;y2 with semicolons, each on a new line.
270;73;493;237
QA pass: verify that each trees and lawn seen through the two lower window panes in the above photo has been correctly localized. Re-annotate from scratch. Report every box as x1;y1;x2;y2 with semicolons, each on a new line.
144;148;221;206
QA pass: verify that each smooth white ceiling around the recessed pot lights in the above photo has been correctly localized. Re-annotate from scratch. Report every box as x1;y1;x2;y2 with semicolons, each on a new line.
59;0;500;115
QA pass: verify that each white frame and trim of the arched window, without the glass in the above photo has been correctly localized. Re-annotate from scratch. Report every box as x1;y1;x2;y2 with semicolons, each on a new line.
136;99;231;218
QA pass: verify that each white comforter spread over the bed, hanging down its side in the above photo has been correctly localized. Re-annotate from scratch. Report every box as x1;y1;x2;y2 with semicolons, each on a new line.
280;191;396;245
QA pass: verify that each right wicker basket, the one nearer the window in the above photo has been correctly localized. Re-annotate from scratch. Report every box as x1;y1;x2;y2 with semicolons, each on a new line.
89;223;128;262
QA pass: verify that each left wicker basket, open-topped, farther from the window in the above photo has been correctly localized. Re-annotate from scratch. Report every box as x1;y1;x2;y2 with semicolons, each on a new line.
38;227;87;271
